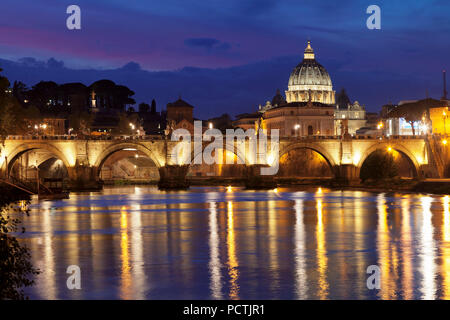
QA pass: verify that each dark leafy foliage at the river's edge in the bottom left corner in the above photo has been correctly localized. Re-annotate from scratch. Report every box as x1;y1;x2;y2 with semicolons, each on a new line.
0;190;40;300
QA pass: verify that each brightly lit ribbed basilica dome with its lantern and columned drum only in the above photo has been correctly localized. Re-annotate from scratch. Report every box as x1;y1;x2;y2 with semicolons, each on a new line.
286;41;335;104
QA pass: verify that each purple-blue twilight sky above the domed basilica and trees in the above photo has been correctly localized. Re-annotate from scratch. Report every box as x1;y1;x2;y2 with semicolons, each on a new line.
0;0;450;118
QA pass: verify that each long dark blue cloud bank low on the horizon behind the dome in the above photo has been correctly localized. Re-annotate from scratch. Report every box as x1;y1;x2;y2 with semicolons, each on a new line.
0;55;442;119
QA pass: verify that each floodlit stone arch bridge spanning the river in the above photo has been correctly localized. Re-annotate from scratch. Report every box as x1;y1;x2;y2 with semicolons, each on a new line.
0;136;443;189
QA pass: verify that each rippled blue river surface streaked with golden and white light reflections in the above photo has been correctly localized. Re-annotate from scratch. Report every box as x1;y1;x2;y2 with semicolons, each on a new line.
14;187;450;299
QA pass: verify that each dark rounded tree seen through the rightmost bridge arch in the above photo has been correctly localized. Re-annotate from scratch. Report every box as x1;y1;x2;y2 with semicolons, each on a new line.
360;149;398;181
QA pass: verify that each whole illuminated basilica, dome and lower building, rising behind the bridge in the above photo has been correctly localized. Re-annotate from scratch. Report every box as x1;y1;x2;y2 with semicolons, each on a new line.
233;41;366;137
